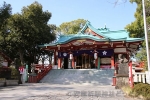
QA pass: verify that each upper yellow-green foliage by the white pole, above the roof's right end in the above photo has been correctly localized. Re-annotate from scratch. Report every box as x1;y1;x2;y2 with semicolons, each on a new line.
125;0;150;38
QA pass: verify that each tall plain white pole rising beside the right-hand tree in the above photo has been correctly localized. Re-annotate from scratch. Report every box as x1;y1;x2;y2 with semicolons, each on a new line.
142;0;150;83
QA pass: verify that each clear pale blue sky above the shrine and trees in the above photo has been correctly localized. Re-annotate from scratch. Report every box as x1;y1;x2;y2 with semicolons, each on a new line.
1;0;136;30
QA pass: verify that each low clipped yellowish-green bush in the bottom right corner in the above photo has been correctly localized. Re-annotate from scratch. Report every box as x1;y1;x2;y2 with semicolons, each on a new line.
131;83;150;100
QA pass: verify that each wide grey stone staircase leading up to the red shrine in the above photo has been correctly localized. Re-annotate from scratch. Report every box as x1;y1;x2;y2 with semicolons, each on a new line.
40;69;114;85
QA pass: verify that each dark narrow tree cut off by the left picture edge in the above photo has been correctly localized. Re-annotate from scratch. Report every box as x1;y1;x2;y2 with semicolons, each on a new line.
0;2;14;57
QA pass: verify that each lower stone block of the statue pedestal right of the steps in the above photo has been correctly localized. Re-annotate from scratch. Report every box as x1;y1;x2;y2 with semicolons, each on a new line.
115;75;129;89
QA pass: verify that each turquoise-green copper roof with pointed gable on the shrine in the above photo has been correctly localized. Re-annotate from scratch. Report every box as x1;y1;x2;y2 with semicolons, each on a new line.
39;21;144;46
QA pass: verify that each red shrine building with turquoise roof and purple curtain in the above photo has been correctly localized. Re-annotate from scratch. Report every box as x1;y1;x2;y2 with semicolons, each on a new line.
40;21;144;69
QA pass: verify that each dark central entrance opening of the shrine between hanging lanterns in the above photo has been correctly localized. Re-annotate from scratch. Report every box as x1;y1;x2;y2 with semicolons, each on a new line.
75;53;94;69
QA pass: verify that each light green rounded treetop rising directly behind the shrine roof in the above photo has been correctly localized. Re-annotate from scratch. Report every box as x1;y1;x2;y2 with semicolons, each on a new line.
57;19;86;34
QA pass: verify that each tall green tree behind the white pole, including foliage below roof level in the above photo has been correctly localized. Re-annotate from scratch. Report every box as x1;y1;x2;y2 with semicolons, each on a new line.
125;0;150;69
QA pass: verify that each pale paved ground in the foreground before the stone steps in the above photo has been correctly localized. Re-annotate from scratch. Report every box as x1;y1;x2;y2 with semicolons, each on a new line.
0;83;140;100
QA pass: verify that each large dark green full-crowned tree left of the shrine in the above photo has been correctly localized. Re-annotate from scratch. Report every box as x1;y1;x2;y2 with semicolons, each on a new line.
8;2;56;65
